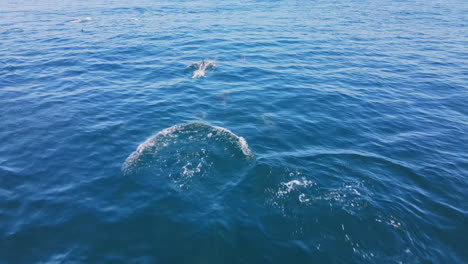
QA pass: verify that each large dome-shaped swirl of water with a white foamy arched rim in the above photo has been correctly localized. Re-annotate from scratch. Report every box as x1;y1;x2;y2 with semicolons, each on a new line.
122;123;253;193
